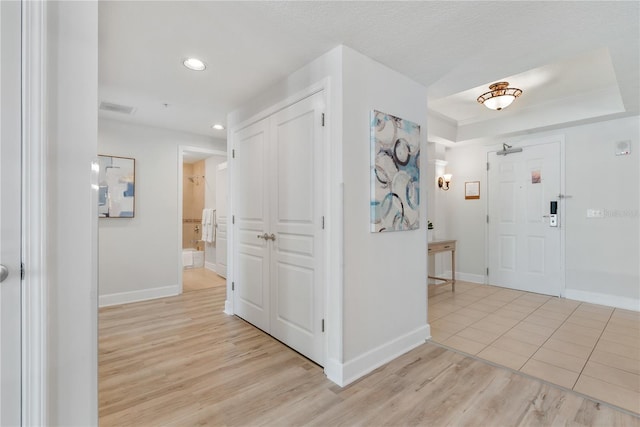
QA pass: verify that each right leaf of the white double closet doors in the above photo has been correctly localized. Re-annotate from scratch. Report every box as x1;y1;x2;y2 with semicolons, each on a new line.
269;93;324;365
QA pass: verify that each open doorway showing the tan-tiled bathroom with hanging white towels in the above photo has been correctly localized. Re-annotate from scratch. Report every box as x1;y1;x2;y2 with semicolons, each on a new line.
178;147;227;292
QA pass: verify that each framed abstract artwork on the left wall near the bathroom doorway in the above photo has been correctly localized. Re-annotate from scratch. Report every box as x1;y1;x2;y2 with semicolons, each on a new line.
98;155;136;218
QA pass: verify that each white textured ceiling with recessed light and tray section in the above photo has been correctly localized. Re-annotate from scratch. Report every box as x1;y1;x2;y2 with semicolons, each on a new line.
99;1;640;140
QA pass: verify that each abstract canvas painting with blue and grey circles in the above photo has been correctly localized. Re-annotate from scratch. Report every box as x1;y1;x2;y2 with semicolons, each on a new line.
371;110;420;233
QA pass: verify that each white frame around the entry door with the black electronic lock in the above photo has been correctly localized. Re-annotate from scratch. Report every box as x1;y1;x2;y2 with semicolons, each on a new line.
484;134;567;298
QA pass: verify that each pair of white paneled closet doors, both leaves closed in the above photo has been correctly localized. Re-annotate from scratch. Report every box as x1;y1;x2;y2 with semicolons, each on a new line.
232;92;324;365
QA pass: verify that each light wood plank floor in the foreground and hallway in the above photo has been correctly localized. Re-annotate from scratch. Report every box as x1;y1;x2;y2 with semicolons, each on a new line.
99;287;640;426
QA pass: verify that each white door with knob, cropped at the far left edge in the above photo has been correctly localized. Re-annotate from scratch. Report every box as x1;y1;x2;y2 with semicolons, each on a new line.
0;1;21;426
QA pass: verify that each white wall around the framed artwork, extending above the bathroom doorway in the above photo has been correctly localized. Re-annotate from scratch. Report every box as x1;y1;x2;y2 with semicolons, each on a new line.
98;119;226;306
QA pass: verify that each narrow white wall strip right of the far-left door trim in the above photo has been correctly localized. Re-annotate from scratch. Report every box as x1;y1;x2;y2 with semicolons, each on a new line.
43;2;98;426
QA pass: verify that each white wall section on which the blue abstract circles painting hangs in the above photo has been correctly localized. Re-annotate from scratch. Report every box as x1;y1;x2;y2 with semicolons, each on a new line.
342;47;429;381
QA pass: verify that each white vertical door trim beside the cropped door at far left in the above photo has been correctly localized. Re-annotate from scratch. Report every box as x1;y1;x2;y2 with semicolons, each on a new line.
21;1;49;426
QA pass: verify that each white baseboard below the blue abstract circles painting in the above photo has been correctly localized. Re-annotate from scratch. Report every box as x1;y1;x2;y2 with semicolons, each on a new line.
336;324;431;387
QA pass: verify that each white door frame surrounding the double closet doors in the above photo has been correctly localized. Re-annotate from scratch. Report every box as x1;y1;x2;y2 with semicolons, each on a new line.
224;77;342;368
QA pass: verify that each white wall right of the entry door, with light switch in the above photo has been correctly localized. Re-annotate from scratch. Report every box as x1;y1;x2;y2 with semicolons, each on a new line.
566;117;640;310
